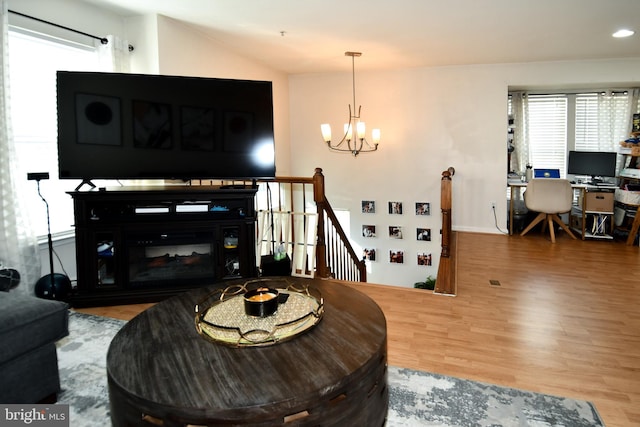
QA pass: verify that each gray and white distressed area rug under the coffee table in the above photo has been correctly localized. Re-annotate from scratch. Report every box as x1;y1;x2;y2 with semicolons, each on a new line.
58;312;604;427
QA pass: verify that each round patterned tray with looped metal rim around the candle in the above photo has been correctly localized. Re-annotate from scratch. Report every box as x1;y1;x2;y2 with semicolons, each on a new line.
195;278;324;347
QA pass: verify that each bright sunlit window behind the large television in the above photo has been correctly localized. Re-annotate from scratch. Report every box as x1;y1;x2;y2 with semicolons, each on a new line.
9;28;100;236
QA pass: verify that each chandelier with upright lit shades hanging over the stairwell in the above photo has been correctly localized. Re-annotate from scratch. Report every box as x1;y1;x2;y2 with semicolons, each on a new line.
320;52;380;156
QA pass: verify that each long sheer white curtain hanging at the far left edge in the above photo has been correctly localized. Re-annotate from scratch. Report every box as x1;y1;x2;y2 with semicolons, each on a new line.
0;0;40;294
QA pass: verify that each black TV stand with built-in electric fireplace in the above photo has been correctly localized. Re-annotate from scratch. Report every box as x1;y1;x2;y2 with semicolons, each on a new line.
68;186;257;306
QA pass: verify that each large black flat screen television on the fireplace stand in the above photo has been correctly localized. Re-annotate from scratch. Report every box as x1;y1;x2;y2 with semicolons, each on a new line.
57;71;275;182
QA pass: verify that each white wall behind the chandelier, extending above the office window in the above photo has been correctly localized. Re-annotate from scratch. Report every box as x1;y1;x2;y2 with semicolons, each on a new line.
290;59;640;287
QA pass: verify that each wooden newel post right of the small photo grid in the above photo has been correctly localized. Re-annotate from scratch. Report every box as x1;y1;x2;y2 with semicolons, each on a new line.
435;167;455;295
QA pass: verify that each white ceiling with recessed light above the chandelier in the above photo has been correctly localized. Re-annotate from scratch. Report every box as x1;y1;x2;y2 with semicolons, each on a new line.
84;0;640;74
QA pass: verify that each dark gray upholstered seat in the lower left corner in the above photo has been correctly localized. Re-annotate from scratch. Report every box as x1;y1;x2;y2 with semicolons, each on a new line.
0;290;69;403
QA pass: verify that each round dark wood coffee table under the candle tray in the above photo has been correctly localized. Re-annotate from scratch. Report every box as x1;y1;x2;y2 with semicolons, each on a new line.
107;277;389;427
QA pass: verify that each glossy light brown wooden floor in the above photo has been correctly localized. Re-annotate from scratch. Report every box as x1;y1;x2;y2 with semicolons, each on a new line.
81;232;640;427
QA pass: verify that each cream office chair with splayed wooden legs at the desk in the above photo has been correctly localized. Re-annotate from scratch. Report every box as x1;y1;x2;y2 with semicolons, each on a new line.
520;178;576;243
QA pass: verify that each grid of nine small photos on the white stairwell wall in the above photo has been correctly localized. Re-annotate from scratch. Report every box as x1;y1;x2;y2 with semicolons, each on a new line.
359;200;439;284
